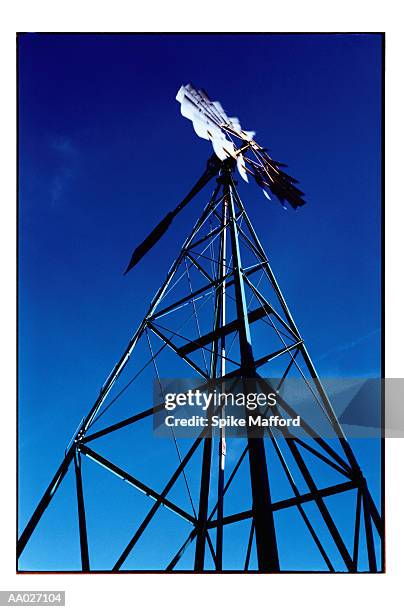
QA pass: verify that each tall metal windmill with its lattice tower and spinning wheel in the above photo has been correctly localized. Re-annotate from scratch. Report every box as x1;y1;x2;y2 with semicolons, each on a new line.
18;85;383;572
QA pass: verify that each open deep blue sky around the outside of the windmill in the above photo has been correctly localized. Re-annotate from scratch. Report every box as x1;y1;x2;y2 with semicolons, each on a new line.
19;34;381;568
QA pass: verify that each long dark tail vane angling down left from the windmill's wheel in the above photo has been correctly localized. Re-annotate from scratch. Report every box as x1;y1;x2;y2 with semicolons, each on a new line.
124;155;220;274
